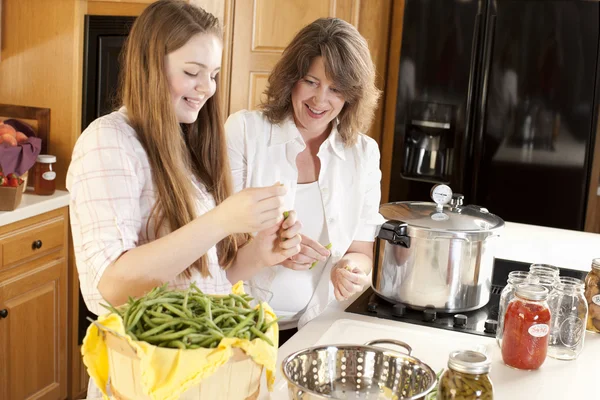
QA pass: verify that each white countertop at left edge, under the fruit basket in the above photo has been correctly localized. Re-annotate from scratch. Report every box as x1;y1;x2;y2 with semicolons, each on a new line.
0;190;69;226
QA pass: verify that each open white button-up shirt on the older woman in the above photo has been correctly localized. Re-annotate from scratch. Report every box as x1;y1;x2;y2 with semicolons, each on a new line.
225;110;384;327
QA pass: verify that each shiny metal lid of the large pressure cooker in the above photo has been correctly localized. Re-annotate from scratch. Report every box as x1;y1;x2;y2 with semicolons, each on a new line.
379;201;504;234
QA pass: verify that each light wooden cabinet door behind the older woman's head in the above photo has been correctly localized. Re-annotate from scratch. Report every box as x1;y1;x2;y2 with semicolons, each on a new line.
229;0;359;113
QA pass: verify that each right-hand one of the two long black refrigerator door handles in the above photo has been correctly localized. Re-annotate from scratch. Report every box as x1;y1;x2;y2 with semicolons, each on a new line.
470;14;496;201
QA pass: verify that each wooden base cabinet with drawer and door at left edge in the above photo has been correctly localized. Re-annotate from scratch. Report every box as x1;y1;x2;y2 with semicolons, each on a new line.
0;208;68;400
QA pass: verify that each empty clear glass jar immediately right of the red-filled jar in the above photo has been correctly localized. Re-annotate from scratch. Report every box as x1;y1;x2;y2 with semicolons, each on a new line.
548;277;588;360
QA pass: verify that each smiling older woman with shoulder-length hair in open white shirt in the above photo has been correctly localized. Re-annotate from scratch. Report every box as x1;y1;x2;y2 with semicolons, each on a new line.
225;18;383;343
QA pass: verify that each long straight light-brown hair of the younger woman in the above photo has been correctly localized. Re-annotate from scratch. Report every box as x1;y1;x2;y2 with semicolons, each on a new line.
120;0;247;277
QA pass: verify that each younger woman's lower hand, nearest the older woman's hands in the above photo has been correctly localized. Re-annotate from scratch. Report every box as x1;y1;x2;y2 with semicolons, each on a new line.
253;211;302;266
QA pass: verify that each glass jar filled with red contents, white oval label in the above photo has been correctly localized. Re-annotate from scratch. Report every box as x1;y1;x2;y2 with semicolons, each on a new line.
502;283;551;370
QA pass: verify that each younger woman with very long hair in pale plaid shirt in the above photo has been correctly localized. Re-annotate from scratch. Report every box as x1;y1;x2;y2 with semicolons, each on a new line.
67;0;301;346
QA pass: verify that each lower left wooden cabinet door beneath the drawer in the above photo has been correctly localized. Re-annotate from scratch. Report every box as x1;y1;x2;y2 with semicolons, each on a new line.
0;258;67;400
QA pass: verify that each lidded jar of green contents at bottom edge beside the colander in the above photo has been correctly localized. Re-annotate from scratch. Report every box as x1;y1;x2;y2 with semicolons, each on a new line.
437;350;494;400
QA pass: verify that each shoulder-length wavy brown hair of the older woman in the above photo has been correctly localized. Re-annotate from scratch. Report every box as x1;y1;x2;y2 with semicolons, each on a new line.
260;18;380;146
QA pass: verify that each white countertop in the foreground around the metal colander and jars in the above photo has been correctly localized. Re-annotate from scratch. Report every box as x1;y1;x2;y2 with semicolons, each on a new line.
259;300;600;400
